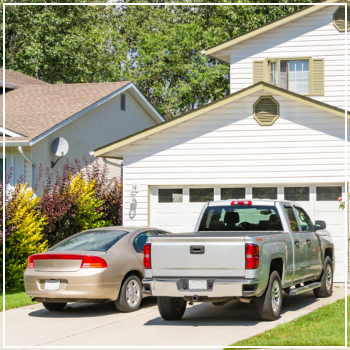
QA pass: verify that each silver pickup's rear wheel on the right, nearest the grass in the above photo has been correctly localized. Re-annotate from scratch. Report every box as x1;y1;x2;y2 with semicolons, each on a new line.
255;271;282;321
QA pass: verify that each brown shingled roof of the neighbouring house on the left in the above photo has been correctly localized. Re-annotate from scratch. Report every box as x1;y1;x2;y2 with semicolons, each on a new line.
0;81;164;144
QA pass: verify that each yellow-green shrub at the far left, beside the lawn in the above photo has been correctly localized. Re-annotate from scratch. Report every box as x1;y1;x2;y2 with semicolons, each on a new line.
0;183;48;288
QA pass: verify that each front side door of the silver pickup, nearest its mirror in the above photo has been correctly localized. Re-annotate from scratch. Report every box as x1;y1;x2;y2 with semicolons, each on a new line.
295;206;322;278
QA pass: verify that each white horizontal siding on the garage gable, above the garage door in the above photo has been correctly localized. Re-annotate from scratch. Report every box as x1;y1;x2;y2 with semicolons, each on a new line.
119;96;345;225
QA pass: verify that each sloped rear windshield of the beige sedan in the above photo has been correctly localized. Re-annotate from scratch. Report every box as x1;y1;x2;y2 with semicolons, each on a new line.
50;230;129;252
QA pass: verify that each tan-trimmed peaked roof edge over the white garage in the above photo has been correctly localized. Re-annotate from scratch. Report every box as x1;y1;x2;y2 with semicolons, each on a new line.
94;82;350;158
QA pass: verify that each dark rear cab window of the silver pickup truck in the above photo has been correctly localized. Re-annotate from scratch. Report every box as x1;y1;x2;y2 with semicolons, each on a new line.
199;205;283;231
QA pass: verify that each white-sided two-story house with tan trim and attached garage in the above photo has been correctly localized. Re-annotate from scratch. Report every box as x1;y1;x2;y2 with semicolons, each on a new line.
94;0;350;281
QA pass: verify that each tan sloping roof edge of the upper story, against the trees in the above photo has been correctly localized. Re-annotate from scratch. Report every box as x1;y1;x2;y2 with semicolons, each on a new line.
204;0;349;63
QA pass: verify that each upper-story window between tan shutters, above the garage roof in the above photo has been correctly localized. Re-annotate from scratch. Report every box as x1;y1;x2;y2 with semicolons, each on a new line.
268;59;310;95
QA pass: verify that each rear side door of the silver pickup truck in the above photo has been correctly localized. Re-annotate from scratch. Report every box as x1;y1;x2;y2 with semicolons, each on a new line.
285;205;307;283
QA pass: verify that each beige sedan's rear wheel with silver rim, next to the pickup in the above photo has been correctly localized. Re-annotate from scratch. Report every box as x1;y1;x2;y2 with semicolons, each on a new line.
114;275;142;312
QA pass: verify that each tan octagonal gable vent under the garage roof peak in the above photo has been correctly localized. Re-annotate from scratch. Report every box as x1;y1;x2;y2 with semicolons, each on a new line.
253;96;279;126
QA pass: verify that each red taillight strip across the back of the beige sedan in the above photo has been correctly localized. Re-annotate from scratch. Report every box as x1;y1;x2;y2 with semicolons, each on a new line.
27;254;107;269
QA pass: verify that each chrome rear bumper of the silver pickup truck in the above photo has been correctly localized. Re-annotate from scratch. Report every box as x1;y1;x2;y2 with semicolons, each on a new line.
142;278;259;298
